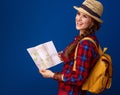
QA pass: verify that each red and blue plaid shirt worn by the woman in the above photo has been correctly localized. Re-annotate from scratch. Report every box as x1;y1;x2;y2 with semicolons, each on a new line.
59;34;99;95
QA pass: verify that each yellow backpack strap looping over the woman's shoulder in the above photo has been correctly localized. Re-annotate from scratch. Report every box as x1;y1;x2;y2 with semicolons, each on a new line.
73;37;107;71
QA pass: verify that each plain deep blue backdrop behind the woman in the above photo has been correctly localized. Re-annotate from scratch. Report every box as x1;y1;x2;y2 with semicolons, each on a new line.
0;0;120;95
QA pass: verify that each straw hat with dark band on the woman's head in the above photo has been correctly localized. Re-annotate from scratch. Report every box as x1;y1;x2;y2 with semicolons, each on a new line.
74;0;103;23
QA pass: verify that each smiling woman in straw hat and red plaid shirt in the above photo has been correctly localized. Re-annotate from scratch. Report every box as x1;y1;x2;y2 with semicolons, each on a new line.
40;0;103;95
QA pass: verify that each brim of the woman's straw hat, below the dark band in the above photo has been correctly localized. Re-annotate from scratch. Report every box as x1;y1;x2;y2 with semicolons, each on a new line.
73;6;103;23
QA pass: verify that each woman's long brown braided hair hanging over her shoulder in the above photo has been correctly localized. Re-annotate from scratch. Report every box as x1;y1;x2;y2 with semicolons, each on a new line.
65;19;101;59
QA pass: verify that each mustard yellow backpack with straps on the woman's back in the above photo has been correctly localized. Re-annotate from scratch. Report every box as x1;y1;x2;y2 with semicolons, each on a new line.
73;37;112;94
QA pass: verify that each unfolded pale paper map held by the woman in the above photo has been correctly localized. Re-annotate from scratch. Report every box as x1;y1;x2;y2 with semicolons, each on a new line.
27;41;62;70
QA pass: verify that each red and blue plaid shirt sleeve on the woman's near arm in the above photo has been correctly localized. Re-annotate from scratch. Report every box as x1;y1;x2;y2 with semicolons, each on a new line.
63;40;93;86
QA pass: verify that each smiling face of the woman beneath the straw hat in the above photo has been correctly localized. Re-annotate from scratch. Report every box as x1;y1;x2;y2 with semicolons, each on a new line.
75;12;93;31
